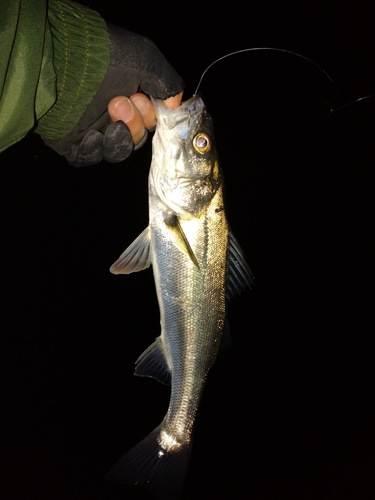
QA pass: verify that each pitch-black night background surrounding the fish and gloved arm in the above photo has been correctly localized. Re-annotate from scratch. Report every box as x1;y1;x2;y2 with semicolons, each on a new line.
0;0;375;500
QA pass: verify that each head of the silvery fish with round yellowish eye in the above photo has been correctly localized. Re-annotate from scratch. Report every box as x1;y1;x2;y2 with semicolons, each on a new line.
150;96;222;219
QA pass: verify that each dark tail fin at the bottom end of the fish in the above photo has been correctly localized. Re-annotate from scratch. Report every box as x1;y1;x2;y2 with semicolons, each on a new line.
106;426;191;500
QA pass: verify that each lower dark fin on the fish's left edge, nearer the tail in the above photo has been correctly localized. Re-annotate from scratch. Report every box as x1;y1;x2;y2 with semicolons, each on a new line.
134;337;171;385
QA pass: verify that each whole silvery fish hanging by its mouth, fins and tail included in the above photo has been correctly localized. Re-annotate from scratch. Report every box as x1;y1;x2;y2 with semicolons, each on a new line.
106;95;253;500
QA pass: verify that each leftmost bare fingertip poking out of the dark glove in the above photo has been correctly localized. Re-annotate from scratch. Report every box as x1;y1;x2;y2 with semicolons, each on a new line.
108;96;146;146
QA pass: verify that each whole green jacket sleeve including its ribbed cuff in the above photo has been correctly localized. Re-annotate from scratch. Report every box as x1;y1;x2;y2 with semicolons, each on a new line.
0;0;110;152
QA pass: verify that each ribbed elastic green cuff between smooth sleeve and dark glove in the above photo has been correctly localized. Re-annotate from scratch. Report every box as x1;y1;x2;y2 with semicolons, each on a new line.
35;0;110;139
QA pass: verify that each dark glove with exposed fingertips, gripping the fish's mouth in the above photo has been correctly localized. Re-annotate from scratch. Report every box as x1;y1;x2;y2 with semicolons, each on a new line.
43;24;184;167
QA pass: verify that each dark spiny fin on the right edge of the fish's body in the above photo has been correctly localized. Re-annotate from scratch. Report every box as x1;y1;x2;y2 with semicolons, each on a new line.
226;231;254;300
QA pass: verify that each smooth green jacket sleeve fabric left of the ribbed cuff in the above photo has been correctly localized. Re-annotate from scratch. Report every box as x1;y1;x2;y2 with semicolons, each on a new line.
0;0;55;152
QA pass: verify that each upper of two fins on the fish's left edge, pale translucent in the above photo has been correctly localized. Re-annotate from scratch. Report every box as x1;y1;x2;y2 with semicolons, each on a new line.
110;227;151;274
